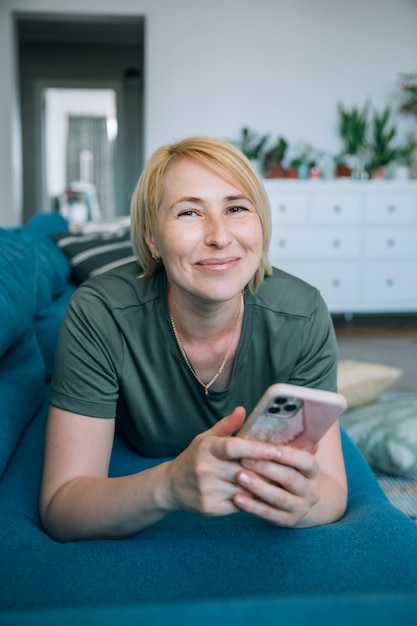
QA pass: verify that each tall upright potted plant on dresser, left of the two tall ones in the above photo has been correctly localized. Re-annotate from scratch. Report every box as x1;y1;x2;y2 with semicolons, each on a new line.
336;103;369;178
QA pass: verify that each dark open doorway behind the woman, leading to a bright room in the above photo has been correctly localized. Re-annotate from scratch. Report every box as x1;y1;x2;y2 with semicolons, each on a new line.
16;16;144;222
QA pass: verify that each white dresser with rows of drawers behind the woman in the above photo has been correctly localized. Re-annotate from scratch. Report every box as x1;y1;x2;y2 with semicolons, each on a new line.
264;179;417;316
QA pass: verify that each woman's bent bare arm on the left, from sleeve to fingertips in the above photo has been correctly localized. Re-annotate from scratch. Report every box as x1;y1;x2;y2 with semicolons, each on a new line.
40;407;272;541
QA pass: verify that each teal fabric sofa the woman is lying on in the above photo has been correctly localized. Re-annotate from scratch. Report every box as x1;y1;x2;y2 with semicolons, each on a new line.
0;214;417;625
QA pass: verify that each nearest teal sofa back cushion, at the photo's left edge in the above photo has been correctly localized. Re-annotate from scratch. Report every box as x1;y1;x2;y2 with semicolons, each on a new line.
0;229;49;475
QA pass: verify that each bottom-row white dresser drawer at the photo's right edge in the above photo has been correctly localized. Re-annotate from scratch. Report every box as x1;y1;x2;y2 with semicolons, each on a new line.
364;262;417;308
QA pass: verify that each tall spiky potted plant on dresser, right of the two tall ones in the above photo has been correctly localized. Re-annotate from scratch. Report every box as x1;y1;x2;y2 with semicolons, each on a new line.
367;107;398;178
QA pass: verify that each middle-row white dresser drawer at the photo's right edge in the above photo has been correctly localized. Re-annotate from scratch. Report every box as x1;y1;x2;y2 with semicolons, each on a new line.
365;227;417;259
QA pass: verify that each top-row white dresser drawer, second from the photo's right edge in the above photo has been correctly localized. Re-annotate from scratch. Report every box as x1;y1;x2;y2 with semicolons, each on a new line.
311;195;362;224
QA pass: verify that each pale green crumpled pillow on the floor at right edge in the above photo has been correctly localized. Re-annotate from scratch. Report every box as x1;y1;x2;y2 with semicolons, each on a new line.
340;394;417;475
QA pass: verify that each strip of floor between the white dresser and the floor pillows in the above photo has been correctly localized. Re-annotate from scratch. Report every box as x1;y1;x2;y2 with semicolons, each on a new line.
333;313;417;392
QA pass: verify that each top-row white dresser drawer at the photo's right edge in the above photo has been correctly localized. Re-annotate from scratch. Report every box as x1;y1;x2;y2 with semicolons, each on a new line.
365;194;417;225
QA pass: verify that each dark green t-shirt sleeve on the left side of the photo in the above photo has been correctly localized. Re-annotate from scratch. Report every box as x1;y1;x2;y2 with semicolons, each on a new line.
50;284;123;418
